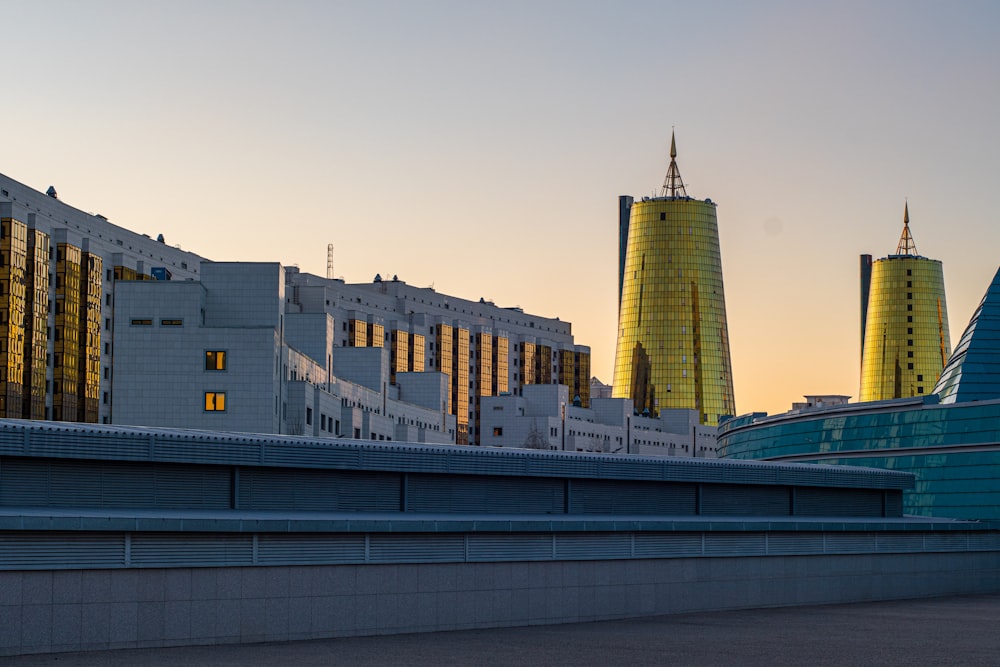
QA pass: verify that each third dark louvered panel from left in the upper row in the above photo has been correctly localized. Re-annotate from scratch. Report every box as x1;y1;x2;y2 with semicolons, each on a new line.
406;474;565;514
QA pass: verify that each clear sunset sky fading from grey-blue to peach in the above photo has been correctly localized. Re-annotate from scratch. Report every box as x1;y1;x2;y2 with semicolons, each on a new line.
0;0;1000;413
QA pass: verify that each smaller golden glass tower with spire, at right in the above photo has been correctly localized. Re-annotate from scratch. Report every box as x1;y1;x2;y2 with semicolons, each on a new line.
859;204;951;401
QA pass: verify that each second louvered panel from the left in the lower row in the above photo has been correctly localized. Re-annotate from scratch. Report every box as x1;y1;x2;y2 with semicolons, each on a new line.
130;533;253;567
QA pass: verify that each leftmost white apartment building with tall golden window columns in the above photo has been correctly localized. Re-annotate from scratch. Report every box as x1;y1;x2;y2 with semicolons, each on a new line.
0;174;203;424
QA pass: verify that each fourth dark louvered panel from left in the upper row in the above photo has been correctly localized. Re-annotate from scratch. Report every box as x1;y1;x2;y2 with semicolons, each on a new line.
569;479;697;516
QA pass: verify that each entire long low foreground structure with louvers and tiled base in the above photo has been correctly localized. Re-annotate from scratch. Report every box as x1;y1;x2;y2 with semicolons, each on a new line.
0;420;1000;655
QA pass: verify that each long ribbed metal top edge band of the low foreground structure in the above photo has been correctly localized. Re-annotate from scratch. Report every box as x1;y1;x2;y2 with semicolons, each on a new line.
0;420;914;490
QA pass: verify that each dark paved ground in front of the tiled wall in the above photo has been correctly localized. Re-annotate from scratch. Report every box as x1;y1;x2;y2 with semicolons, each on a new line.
7;594;1000;667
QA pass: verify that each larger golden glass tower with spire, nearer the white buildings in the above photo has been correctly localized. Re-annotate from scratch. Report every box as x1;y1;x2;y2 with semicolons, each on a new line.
612;136;736;425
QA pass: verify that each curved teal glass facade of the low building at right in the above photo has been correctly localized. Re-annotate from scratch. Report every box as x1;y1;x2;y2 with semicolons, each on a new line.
719;395;1000;520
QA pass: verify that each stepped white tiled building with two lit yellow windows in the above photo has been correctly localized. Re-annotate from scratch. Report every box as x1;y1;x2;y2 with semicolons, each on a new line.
113;262;455;443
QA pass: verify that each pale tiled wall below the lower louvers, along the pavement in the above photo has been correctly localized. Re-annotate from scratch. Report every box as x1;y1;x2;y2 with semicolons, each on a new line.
0;551;1000;655
